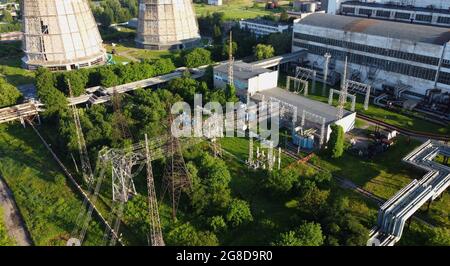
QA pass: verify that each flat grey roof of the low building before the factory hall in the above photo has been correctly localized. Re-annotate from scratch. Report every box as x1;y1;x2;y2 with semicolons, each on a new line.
259;88;353;124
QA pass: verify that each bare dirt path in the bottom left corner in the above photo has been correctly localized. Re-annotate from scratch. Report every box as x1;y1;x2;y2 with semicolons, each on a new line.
0;176;33;246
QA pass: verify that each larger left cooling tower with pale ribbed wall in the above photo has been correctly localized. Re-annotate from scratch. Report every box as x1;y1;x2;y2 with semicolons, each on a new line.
22;0;106;70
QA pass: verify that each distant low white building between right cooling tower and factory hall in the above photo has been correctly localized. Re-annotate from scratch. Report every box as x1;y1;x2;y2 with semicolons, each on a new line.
239;19;289;36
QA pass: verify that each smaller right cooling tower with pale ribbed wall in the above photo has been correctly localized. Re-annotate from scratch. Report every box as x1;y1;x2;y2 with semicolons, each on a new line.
136;0;200;50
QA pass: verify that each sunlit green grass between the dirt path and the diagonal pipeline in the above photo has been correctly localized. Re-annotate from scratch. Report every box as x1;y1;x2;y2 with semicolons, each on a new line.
0;124;103;246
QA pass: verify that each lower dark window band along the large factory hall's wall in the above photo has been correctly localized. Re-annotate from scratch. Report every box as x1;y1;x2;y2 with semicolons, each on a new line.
293;41;450;85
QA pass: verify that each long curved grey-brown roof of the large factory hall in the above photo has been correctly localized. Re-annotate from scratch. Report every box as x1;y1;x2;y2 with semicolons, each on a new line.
298;13;450;45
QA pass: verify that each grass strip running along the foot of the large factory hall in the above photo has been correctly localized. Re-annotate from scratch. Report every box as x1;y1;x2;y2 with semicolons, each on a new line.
279;74;450;135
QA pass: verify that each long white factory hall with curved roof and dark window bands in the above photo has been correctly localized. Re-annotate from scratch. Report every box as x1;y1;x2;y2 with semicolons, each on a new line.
292;14;450;99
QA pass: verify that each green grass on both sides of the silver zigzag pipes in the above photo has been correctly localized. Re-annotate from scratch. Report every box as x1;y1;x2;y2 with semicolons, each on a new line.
310;137;450;229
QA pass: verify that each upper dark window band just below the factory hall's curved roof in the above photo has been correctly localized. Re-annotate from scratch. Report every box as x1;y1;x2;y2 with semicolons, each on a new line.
294;32;439;66
